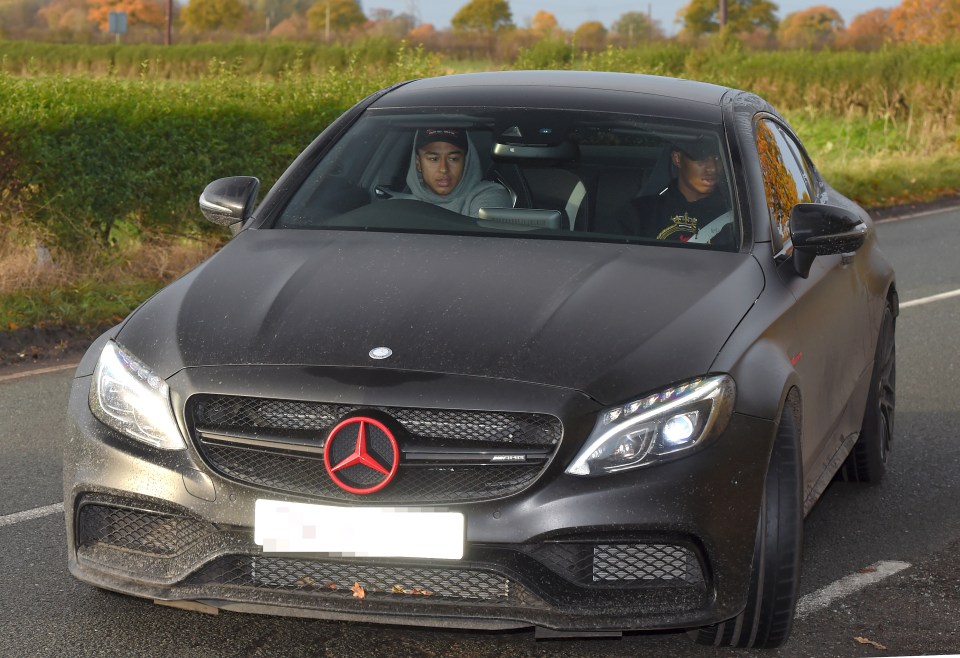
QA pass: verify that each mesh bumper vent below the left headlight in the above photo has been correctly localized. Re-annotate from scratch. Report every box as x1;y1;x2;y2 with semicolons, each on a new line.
77;504;214;556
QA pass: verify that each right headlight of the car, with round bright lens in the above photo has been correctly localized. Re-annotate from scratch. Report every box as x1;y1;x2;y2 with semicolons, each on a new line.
567;375;736;475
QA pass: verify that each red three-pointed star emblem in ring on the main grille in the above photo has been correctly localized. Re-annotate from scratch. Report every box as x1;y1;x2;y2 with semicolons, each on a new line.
323;416;400;494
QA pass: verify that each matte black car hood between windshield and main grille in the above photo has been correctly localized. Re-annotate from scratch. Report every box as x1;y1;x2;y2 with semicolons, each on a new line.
117;230;764;404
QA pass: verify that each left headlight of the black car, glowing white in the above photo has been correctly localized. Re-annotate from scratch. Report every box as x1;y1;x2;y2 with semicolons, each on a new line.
90;342;187;450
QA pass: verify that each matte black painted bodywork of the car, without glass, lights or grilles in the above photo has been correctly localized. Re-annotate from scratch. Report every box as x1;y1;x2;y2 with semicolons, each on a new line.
64;72;896;631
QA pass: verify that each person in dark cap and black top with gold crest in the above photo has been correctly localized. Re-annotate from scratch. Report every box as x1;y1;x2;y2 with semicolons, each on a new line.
619;137;734;246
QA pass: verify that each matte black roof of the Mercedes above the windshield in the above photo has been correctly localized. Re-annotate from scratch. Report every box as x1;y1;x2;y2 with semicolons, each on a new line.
371;71;730;123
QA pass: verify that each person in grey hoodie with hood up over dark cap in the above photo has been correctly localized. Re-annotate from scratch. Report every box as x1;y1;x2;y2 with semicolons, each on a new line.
393;128;513;217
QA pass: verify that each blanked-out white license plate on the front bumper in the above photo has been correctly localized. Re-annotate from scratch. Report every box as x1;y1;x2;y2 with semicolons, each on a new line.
253;500;464;560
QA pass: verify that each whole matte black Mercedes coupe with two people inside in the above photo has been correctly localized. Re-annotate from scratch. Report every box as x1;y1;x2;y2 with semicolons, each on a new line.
64;71;898;647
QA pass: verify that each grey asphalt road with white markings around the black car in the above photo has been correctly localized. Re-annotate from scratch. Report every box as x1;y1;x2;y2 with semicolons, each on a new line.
0;211;960;658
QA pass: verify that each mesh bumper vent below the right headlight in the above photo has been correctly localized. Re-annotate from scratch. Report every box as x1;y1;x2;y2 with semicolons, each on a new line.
525;542;704;588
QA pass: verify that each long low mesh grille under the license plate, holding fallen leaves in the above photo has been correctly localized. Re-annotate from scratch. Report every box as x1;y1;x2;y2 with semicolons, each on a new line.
184;555;536;605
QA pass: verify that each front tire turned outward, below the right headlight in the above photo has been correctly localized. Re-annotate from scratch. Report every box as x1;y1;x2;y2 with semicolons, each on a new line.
694;391;803;649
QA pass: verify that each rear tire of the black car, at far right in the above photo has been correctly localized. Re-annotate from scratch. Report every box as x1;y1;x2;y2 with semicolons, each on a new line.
840;304;897;484
